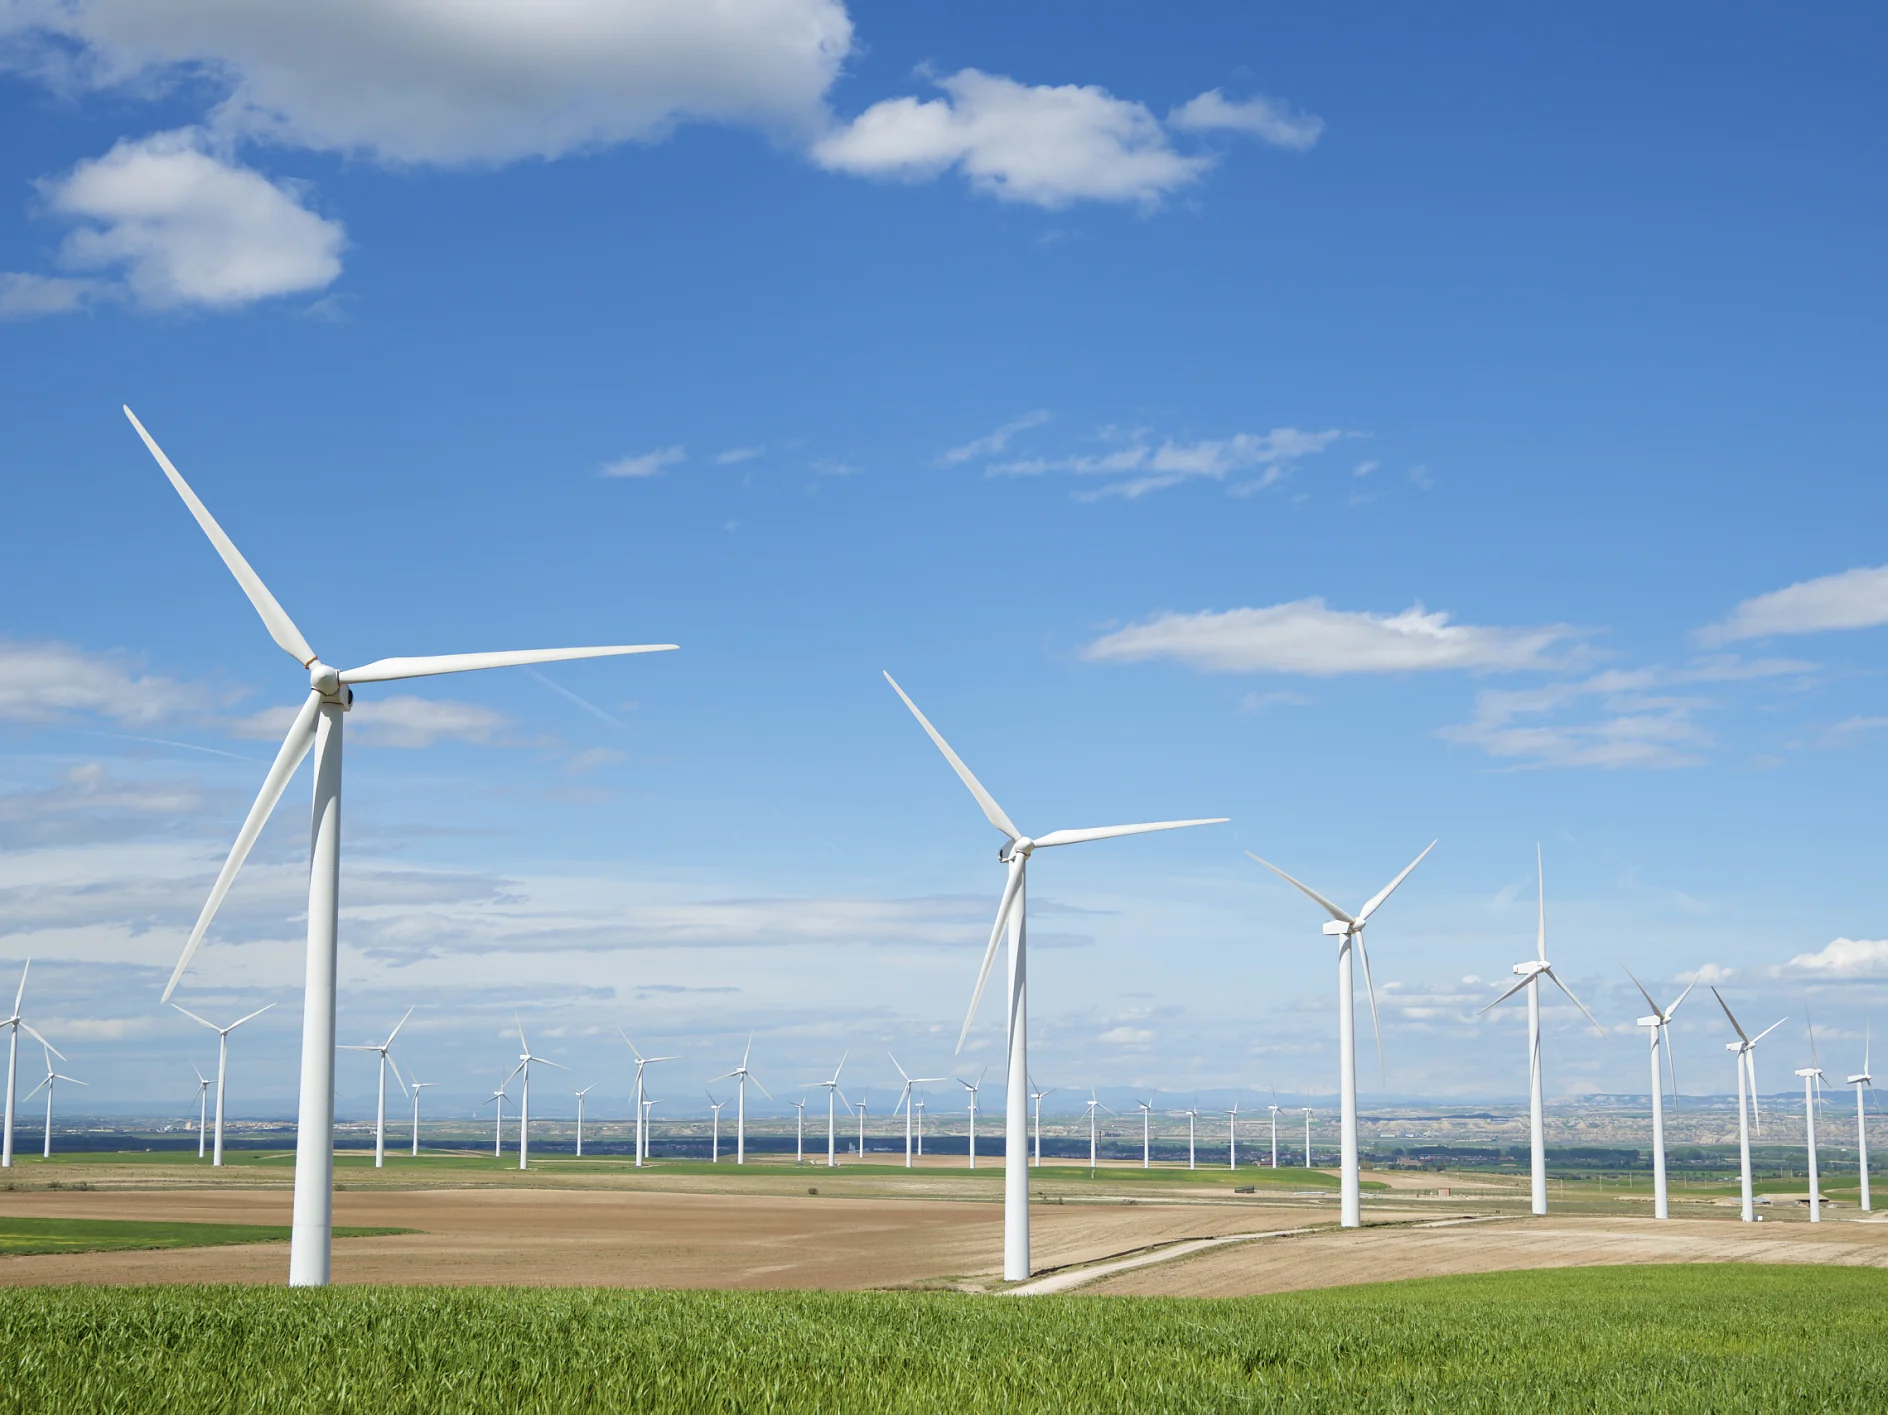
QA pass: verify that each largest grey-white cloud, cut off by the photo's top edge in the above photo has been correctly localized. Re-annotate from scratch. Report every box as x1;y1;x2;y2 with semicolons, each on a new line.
0;0;851;164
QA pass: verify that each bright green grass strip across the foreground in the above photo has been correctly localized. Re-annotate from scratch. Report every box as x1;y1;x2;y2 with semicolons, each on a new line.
0;1266;1888;1415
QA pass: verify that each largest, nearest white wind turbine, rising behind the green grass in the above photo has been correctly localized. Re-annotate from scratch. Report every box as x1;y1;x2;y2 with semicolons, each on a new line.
125;408;674;1287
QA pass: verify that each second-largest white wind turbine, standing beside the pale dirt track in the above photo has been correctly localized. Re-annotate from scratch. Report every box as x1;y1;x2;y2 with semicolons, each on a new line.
885;673;1225;1283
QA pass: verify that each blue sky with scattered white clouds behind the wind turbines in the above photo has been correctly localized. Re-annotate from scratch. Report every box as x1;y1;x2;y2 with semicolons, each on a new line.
0;0;1888;1113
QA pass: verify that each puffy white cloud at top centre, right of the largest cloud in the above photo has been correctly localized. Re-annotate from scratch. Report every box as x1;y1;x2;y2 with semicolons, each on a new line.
812;68;1214;210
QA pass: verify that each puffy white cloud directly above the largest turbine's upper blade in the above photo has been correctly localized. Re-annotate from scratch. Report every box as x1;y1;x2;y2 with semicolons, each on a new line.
23;130;347;314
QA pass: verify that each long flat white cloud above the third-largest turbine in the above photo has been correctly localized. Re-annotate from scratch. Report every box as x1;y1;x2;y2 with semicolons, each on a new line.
1084;599;1582;678
